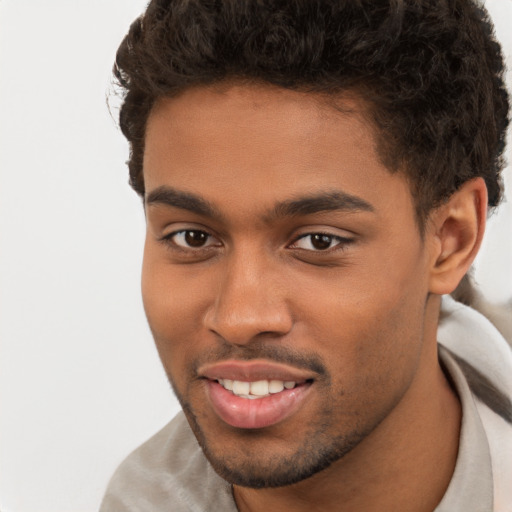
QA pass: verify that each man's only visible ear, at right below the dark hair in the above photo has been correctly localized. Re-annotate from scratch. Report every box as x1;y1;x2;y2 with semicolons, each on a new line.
427;178;487;295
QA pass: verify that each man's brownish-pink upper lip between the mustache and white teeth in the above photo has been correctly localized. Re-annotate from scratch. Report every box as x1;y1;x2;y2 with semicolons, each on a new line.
198;360;314;383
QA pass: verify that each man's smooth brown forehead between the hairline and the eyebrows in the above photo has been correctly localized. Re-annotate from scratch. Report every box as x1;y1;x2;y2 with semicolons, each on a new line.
144;85;412;224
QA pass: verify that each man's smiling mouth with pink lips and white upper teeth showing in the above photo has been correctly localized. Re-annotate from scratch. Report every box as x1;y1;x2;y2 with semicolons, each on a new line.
198;361;314;429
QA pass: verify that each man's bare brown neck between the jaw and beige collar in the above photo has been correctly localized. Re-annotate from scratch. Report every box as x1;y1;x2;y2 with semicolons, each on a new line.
234;298;461;512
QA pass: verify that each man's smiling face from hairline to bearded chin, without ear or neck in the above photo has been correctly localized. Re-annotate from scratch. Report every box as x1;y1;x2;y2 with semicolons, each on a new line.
142;85;434;487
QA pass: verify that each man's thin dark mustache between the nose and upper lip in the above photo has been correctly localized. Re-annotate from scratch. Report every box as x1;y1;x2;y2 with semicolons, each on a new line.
193;342;329;378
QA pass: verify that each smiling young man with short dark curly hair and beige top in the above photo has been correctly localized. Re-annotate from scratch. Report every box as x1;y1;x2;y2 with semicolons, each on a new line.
101;0;512;512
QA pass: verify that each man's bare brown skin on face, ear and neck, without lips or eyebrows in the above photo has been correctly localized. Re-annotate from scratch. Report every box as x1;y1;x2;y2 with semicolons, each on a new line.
142;84;486;512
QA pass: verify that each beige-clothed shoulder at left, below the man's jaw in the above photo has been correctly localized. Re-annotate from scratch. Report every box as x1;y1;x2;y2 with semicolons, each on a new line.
100;412;234;512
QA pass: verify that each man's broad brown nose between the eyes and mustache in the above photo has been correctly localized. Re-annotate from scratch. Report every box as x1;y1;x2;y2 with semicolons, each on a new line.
204;247;293;345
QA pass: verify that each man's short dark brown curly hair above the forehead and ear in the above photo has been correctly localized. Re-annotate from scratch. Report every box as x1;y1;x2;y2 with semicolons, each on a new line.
114;0;509;221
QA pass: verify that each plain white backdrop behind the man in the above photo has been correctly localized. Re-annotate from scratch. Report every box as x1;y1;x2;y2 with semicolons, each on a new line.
0;0;512;512
